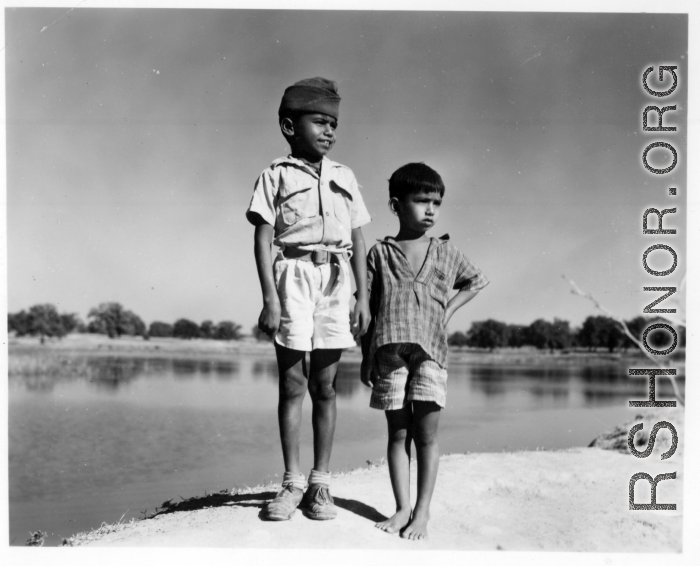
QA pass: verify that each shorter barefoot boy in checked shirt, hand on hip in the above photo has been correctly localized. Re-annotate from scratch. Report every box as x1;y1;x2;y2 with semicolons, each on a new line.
361;163;488;540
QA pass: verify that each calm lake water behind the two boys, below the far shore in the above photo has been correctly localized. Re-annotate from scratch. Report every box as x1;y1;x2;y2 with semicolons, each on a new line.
9;352;684;545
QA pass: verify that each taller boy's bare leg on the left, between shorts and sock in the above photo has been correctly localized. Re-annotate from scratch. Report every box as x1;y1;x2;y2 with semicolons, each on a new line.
275;344;307;473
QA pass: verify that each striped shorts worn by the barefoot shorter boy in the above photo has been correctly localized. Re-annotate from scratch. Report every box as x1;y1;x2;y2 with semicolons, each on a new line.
369;343;447;411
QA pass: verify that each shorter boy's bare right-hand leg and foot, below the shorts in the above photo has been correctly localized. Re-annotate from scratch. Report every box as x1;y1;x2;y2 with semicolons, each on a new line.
401;401;440;540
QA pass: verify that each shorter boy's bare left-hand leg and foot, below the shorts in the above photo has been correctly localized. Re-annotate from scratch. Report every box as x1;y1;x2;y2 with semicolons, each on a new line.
374;404;412;533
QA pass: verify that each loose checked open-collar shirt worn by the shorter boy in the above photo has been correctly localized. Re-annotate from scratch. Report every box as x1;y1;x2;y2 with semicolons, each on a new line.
362;235;489;367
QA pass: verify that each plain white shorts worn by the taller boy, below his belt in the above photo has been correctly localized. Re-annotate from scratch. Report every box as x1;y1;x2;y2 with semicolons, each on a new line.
274;256;355;352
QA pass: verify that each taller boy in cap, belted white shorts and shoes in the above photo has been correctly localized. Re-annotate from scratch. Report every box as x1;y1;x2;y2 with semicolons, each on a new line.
246;77;370;521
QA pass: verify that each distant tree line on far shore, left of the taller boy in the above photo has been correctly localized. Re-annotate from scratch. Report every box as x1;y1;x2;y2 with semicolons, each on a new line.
7;302;243;342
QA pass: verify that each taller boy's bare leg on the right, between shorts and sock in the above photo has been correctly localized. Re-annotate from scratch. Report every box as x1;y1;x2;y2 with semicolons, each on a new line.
309;350;342;472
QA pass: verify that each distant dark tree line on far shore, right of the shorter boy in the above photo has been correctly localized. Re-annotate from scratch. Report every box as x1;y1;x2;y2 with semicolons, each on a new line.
448;316;685;352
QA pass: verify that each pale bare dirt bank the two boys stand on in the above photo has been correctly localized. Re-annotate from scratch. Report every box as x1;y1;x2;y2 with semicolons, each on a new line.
72;409;684;553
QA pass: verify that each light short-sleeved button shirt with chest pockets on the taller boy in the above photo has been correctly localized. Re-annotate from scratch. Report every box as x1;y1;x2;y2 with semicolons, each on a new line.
246;155;371;252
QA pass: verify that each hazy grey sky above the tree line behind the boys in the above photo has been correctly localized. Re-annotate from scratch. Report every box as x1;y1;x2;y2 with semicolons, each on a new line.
5;8;688;330
